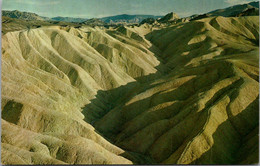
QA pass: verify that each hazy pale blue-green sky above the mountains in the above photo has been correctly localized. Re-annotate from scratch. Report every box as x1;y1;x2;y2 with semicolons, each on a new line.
2;0;255;18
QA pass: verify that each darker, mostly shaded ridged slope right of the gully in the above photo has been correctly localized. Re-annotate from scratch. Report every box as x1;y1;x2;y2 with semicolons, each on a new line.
94;17;259;164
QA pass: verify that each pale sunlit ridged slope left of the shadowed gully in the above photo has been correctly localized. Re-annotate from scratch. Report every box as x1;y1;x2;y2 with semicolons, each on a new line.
2;24;159;164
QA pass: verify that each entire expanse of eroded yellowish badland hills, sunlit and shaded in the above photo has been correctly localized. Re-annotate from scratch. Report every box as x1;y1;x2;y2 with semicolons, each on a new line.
1;16;259;164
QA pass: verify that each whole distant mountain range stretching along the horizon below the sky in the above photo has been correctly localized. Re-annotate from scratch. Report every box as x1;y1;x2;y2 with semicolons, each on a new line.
2;1;259;25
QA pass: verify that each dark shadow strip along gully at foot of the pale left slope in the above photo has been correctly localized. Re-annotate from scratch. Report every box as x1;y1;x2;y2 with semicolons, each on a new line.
82;30;169;164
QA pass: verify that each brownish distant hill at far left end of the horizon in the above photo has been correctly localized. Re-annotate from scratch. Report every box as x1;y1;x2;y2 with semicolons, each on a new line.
2;10;48;21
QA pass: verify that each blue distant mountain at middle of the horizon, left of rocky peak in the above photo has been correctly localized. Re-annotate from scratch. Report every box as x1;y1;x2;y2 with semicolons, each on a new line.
101;14;162;23
